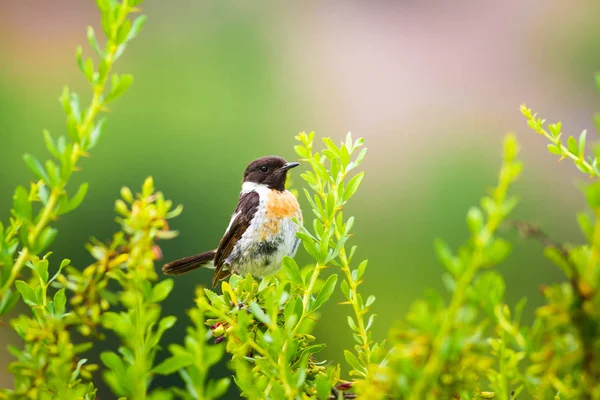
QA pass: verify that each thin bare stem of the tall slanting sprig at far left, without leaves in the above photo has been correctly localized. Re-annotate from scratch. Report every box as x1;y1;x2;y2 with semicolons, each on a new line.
0;0;128;298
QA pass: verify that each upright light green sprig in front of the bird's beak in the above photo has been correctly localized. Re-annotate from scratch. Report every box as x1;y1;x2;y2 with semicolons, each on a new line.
295;132;378;378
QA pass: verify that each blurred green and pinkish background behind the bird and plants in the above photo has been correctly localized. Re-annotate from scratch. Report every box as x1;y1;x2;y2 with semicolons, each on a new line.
0;0;600;398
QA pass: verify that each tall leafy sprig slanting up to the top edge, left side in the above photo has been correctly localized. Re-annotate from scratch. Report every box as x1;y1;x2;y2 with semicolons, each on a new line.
0;0;145;315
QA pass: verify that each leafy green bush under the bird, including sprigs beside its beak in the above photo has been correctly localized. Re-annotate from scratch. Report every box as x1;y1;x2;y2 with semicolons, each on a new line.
157;133;375;399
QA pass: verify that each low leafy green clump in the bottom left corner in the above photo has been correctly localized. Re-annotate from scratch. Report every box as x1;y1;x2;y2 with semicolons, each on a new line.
5;257;97;399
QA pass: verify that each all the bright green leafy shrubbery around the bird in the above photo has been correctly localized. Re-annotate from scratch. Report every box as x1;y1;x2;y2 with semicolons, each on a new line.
0;0;600;400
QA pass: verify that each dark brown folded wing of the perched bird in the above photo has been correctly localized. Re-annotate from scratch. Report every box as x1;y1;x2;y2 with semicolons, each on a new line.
213;191;260;286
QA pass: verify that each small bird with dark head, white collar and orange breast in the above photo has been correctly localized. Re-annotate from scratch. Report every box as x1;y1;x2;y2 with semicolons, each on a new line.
162;156;302;287
